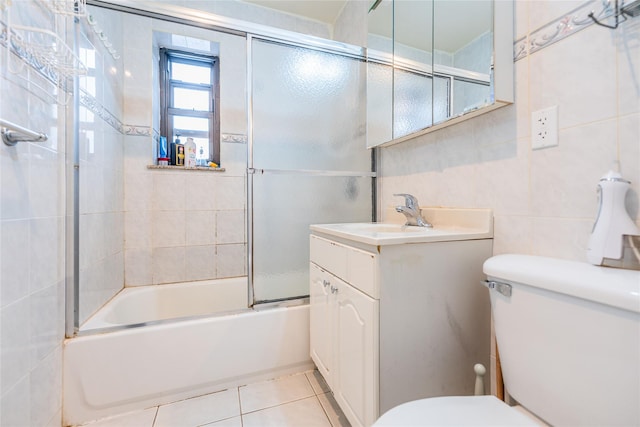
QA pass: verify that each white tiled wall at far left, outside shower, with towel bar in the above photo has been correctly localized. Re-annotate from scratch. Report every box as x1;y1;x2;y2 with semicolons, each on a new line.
0;2;65;426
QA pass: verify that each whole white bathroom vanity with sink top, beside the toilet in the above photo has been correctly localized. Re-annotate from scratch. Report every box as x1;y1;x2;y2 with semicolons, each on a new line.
310;208;493;426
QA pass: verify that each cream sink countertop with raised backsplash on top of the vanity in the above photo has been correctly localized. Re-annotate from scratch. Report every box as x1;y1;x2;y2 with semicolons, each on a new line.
310;208;493;246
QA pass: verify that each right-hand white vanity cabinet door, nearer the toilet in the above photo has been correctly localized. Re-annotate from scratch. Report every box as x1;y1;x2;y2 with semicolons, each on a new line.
333;281;378;426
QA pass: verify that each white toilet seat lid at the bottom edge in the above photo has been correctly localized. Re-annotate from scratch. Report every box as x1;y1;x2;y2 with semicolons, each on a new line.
373;396;540;427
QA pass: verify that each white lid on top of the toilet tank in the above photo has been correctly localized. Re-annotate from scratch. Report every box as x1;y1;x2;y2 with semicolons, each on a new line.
483;254;640;313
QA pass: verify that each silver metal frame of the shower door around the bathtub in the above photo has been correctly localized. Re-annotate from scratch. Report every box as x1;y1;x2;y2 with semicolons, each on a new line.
65;0;377;338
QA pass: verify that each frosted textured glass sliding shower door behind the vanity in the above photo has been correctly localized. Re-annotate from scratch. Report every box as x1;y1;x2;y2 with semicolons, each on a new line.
249;38;374;303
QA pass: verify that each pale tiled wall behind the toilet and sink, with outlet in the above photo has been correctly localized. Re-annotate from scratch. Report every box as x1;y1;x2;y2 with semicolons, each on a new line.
379;1;640;268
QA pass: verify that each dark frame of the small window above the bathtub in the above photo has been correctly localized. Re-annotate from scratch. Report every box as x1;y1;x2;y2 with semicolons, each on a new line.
160;48;220;165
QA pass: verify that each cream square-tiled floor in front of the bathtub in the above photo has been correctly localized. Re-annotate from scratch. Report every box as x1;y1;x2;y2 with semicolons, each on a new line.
79;371;350;427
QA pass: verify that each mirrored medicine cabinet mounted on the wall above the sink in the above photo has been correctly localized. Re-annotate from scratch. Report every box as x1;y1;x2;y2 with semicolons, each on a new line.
367;0;513;147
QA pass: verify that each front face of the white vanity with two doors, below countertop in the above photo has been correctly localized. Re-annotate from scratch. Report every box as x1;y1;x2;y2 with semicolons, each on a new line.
309;236;379;426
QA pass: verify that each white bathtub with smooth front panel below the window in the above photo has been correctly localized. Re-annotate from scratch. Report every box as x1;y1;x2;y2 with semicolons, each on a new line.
63;279;313;425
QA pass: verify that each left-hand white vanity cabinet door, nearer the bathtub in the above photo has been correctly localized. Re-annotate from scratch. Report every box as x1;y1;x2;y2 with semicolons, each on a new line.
309;263;335;388
